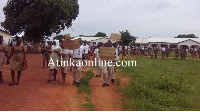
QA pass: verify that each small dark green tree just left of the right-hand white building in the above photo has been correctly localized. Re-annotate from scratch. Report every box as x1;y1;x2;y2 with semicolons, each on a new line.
120;30;136;46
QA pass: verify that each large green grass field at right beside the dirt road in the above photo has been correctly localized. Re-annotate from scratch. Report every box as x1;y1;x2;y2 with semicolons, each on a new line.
120;57;200;111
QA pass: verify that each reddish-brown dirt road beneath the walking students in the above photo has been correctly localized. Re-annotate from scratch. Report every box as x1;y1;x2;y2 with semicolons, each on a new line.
0;54;120;111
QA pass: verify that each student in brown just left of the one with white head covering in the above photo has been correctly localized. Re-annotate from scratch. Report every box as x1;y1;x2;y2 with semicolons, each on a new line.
41;40;50;69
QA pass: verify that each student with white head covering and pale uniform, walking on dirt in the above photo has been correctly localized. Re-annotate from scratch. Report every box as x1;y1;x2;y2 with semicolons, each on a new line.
47;40;62;82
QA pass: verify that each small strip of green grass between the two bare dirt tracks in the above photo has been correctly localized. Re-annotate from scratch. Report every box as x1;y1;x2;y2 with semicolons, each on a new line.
78;71;94;94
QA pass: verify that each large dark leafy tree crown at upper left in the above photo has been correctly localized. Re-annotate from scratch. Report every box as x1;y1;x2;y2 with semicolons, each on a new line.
1;0;79;42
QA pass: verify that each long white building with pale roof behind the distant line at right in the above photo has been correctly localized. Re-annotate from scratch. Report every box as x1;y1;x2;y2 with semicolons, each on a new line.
135;37;200;48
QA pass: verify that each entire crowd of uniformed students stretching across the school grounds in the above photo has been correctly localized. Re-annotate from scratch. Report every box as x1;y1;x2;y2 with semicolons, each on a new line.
0;35;200;87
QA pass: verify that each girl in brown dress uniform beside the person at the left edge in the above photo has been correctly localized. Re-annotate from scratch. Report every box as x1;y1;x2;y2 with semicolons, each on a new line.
7;37;27;86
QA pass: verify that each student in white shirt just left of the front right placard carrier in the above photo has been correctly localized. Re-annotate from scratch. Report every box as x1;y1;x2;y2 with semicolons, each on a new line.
94;45;102;77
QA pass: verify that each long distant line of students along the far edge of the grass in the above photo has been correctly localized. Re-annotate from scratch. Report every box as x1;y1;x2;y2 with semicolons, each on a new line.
122;46;200;60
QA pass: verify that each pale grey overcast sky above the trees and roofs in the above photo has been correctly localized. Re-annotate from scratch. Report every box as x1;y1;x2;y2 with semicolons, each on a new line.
0;0;200;38
